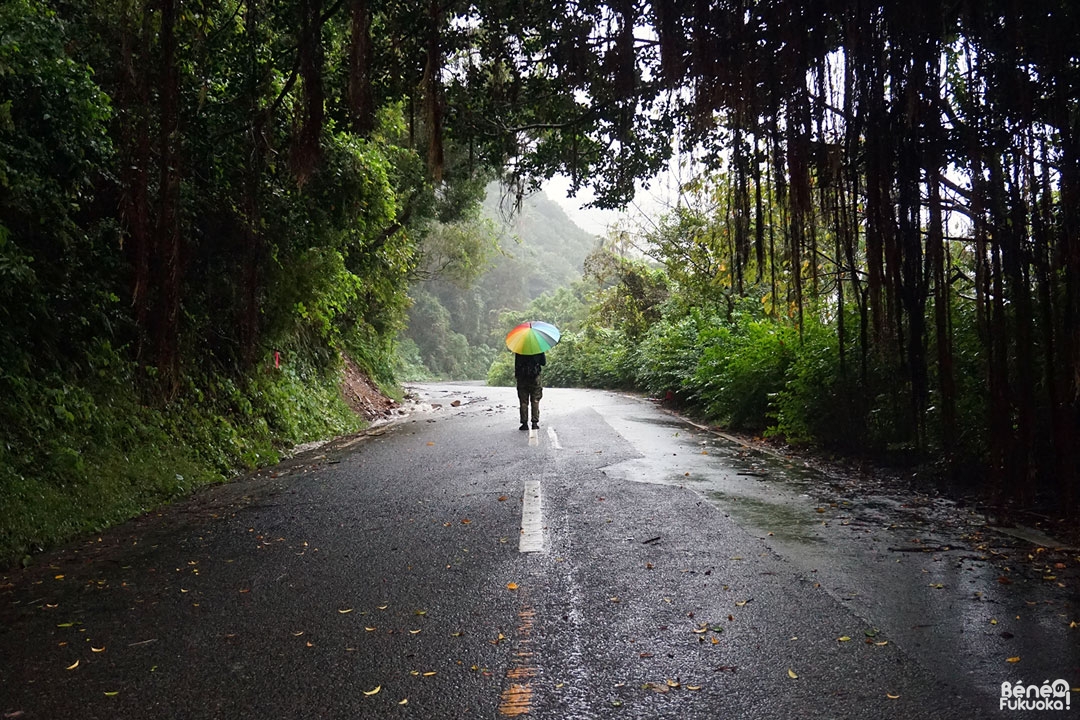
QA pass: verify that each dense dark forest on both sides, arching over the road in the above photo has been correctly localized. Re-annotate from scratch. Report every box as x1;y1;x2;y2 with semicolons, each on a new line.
0;0;1080;553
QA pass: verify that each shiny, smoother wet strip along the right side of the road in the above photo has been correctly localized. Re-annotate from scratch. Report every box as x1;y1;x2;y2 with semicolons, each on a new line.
595;398;1080;702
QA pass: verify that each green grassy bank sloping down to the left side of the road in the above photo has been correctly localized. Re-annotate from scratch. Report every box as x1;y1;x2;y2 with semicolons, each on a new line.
0;360;363;568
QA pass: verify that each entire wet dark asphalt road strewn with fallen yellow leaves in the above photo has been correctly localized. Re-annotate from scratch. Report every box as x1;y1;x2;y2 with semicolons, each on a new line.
0;385;1080;720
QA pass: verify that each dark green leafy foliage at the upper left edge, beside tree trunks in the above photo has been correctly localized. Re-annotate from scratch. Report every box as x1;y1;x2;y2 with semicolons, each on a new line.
0;0;120;379
